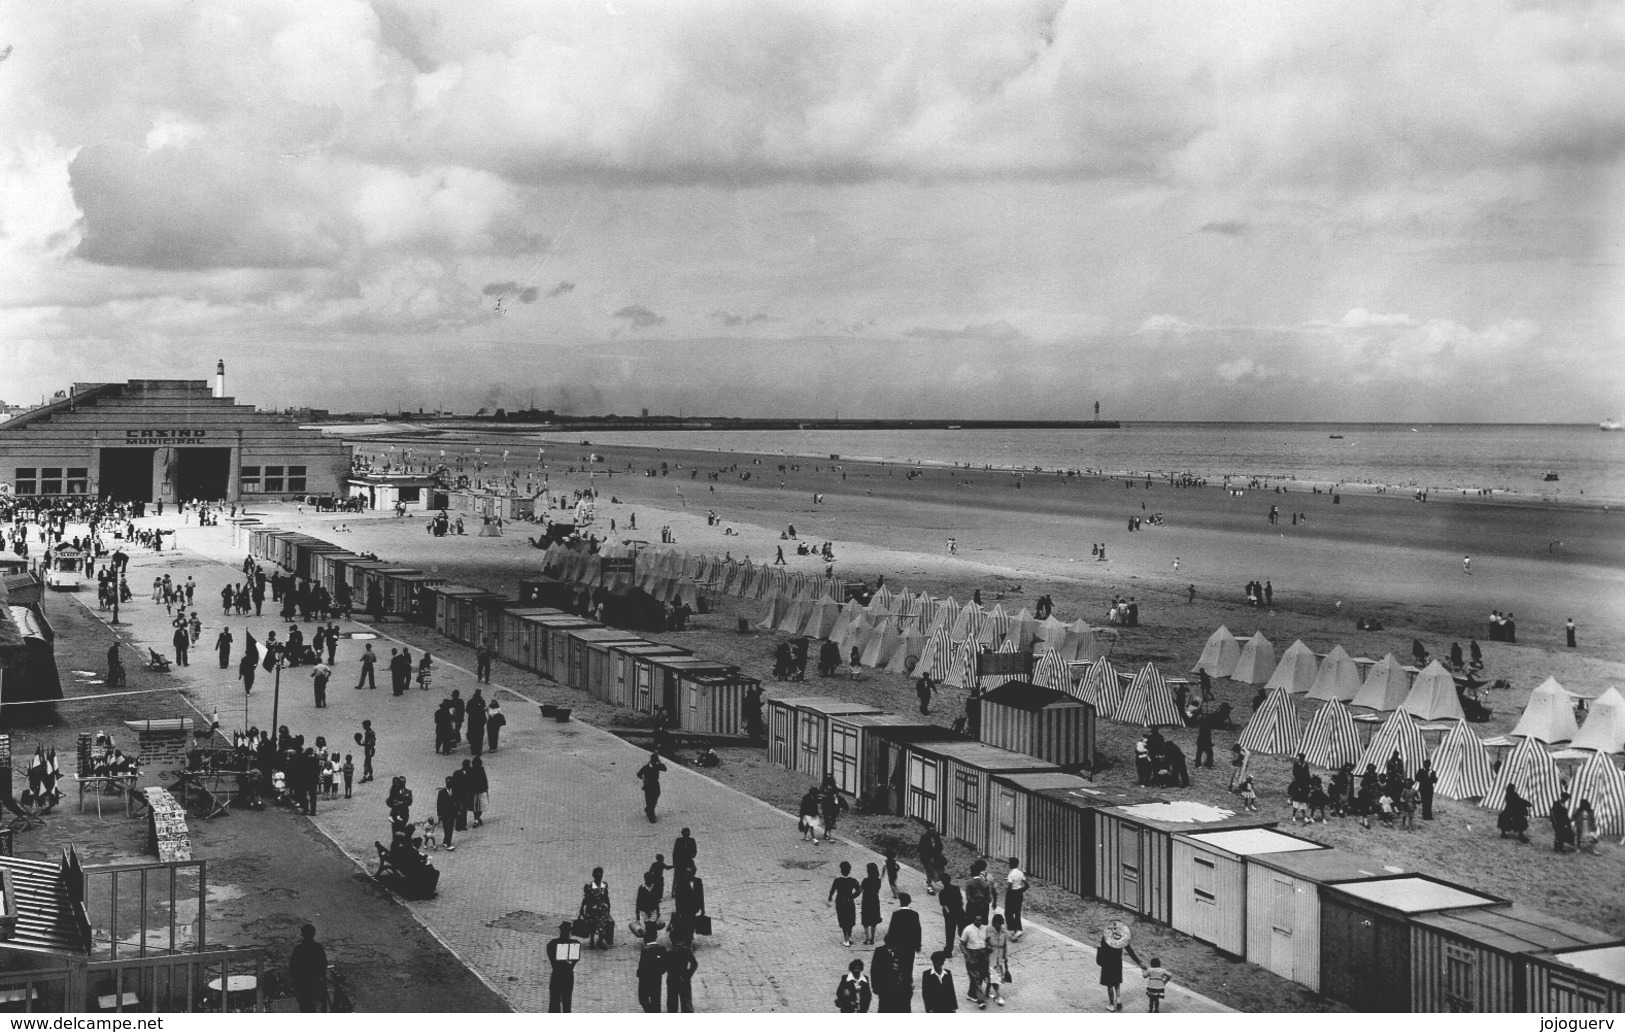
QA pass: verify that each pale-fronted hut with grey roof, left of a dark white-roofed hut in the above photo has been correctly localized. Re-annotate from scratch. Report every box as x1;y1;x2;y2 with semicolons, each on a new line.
1246;850;1399;991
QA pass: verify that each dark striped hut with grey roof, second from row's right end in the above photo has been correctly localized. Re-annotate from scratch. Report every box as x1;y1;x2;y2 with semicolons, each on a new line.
1411;904;1615;1014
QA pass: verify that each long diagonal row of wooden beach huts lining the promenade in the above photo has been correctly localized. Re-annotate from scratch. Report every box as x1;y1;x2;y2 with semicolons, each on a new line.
245;527;1625;1012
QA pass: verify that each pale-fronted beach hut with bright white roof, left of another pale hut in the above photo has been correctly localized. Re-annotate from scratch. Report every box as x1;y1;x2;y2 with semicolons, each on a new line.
1170;827;1326;956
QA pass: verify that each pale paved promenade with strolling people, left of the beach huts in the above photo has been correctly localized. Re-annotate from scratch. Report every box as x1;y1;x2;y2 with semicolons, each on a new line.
81;517;1225;1012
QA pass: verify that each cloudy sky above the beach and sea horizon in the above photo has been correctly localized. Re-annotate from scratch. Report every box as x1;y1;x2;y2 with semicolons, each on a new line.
0;0;1625;421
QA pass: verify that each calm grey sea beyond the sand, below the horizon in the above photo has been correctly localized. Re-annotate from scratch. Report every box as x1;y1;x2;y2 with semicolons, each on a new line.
527;423;1625;504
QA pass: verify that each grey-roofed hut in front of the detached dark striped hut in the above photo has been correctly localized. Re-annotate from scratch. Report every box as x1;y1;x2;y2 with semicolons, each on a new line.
904;741;1060;852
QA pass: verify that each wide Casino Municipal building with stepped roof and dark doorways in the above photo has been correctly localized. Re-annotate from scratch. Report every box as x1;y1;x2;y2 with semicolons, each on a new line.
0;362;349;502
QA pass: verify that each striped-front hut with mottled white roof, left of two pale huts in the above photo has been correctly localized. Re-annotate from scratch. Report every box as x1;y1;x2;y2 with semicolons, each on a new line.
1094;803;1276;925
